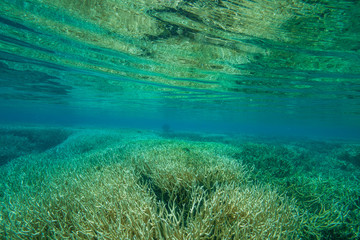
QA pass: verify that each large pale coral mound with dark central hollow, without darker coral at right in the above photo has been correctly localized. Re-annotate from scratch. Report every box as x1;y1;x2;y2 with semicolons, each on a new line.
0;130;300;239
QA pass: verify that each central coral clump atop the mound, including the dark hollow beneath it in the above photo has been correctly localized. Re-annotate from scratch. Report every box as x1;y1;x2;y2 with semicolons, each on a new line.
127;141;248;225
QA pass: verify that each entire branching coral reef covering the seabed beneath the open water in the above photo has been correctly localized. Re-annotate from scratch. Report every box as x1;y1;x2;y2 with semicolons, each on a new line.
0;128;360;239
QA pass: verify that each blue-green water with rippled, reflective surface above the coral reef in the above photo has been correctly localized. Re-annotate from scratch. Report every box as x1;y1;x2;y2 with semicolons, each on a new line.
0;0;360;136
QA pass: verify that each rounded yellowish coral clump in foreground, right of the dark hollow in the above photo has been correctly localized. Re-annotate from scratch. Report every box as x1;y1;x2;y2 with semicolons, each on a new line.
184;184;299;239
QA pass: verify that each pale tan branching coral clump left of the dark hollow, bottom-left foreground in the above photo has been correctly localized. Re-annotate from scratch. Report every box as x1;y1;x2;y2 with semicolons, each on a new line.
2;163;162;239
